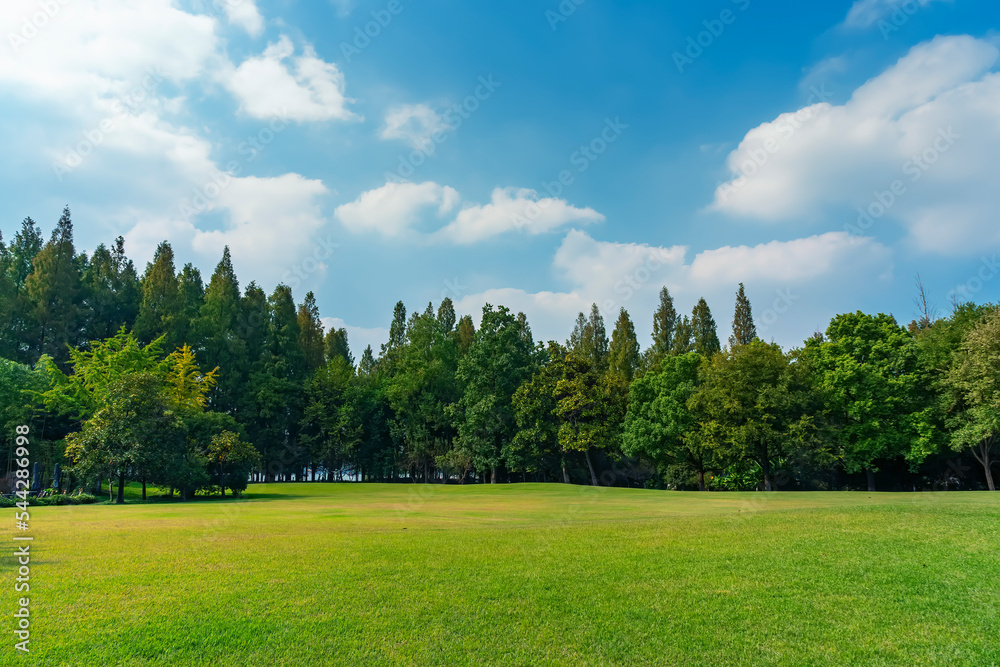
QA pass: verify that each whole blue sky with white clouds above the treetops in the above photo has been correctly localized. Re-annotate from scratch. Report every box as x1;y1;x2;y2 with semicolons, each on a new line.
0;0;1000;352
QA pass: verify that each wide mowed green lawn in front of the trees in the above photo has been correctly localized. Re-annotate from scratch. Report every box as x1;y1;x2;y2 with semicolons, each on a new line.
0;484;1000;666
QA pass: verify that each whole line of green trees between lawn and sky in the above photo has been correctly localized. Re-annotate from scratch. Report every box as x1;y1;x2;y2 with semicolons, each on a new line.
0;209;1000;500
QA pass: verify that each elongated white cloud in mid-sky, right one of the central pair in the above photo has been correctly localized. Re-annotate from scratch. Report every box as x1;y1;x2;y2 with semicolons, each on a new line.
436;188;604;245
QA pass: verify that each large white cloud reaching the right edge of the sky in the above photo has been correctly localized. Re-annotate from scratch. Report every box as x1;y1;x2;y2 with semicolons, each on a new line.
711;36;1000;254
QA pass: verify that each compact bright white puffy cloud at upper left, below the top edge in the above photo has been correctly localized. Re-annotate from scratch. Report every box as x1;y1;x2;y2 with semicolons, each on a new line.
226;35;360;121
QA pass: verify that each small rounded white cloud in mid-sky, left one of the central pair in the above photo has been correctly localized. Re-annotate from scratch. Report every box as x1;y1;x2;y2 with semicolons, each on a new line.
334;182;459;237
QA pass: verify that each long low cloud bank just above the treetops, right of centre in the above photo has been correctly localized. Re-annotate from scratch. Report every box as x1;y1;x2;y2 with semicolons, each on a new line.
456;230;892;346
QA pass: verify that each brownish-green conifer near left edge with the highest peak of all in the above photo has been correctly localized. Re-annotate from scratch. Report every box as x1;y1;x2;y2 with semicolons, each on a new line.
25;207;82;362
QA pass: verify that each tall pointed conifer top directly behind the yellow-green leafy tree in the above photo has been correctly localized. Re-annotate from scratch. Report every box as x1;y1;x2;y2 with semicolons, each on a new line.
135;241;184;350
